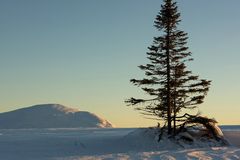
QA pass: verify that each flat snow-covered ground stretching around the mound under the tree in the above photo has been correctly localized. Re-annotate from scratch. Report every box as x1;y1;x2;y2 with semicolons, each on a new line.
0;128;240;160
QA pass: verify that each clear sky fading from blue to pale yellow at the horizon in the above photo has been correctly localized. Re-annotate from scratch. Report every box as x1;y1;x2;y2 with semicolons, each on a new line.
0;0;240;127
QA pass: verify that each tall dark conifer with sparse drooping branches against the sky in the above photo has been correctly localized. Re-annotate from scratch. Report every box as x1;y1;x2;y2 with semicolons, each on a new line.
126;0;210;134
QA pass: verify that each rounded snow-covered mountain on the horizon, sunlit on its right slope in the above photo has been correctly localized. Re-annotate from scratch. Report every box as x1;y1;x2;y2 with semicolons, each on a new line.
0;104;113;129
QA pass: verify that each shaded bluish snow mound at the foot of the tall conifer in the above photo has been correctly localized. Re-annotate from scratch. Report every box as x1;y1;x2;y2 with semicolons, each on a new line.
123;127;228;150
